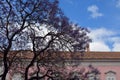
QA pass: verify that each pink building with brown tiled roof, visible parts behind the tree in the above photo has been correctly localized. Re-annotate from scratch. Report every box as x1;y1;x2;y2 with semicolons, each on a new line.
0;50;120;80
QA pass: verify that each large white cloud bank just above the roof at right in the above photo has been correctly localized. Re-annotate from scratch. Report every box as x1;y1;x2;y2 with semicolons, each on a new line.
89;28;120;51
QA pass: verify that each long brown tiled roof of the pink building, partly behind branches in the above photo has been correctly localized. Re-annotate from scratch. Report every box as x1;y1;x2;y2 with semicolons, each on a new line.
0;51;120;59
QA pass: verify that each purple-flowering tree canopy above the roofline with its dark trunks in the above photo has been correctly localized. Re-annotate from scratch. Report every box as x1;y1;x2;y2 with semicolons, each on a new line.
0;0;90;80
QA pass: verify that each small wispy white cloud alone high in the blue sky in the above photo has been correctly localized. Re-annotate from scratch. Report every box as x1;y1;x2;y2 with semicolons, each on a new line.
87;5;103;18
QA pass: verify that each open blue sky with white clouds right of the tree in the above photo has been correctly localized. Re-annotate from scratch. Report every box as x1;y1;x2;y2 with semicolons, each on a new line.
59;0;120;51
